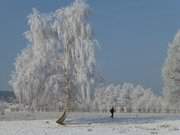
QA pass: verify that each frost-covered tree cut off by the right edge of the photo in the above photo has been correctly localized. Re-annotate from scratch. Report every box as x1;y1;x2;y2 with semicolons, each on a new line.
162;31;180;110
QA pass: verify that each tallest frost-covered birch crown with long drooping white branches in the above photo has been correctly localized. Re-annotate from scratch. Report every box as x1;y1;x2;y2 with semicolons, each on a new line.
55;0;97;108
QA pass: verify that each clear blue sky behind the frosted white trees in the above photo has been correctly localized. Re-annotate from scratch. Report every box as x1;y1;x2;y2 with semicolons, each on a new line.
0;0;180;94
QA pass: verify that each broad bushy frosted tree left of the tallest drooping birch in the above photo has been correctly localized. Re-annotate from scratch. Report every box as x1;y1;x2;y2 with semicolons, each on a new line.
10;9;63;110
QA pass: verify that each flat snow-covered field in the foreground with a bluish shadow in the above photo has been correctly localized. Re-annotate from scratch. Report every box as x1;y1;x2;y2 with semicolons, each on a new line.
0;113;180;135
